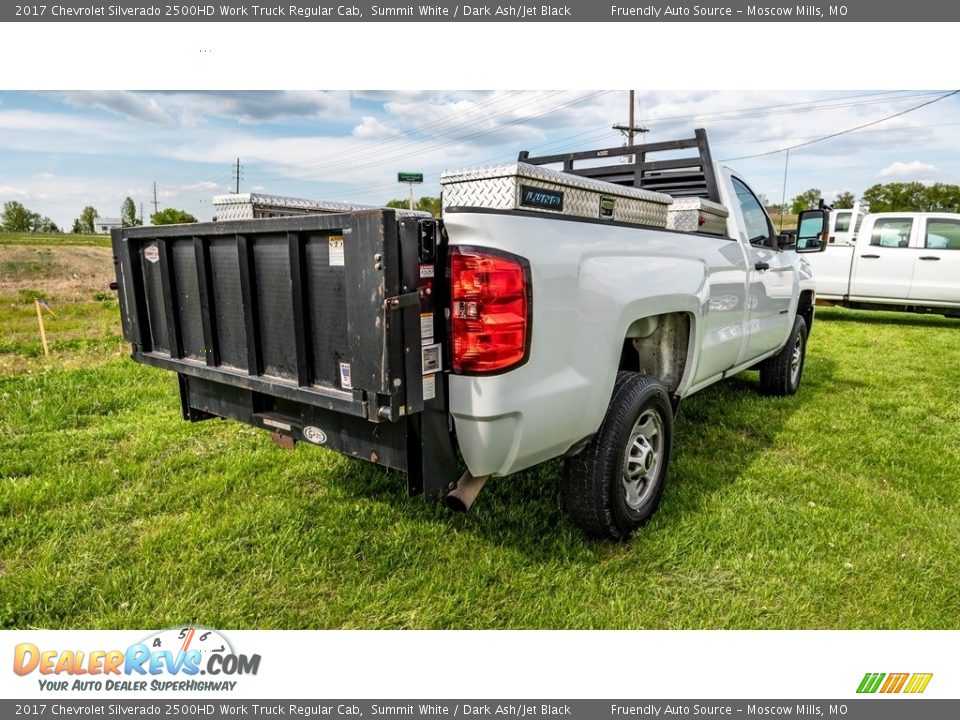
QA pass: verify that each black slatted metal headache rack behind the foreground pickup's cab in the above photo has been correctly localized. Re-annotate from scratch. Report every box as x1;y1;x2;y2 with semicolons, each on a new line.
518;128;720;203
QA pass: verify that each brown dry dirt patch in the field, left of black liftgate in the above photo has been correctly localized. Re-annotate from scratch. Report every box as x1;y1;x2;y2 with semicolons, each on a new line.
0;245;115;300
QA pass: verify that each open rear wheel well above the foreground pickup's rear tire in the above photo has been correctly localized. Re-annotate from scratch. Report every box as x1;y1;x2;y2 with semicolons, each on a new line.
618;312;690;395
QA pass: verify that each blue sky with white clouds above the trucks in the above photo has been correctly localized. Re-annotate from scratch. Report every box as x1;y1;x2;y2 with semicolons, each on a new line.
0;90;960;229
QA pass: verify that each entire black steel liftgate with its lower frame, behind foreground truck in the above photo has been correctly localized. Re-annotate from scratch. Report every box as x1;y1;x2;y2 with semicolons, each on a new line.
113;210;452;492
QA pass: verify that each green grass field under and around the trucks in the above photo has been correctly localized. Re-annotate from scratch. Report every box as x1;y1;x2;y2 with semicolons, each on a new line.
0;239;960;628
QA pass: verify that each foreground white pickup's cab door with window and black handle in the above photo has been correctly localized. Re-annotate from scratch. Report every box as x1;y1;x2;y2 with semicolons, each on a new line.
730;177;794;363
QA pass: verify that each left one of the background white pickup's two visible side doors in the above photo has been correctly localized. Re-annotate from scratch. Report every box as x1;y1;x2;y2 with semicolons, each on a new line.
850;215;918;300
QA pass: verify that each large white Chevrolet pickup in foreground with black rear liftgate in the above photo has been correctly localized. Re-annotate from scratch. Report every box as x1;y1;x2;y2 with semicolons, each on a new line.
113;130;827;538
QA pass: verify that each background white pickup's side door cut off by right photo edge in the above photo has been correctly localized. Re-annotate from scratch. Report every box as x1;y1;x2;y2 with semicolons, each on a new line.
910;217;960;305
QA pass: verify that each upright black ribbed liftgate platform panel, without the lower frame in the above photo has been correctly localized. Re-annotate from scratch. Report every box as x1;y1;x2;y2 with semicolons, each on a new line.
113;210;430;423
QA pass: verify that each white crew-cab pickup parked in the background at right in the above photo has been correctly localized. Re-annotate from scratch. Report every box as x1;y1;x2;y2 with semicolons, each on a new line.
810;212;960;317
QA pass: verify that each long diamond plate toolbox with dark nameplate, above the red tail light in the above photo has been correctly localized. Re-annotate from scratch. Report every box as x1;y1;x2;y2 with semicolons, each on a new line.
440;162;672;228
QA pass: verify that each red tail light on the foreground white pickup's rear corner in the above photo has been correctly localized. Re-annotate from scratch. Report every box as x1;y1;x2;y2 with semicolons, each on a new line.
450;247;530;373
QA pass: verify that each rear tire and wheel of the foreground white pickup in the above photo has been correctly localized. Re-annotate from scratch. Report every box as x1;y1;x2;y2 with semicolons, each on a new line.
563;372;673;540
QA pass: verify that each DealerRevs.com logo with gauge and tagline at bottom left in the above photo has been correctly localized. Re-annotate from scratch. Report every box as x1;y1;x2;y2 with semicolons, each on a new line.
13;626;260;692
